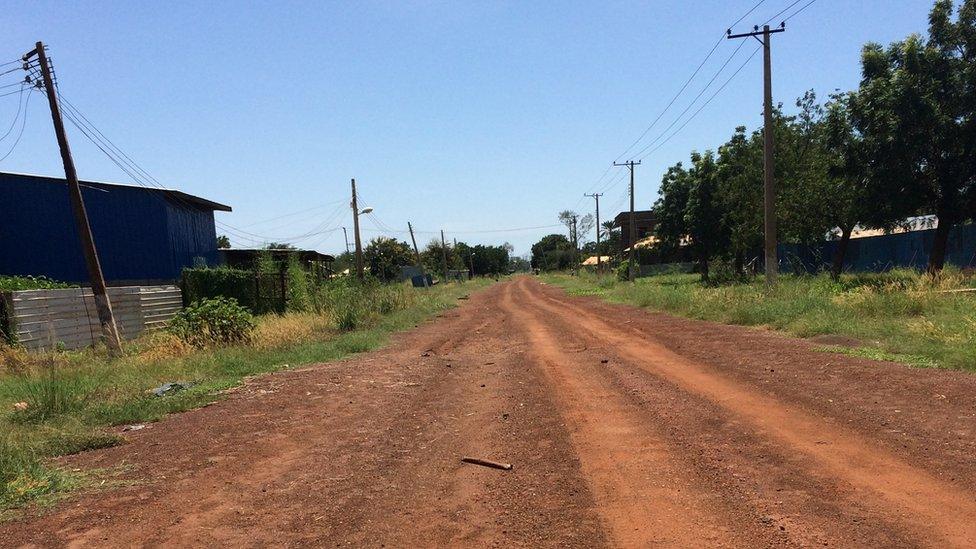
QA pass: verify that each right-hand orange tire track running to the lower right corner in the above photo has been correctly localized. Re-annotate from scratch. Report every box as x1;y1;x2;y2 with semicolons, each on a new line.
518;279;976;547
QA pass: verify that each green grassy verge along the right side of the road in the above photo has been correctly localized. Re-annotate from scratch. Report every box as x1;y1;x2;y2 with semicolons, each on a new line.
543;270;976;370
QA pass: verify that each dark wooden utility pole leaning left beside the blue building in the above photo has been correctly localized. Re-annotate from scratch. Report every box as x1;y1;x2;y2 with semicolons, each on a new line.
23;42;122;353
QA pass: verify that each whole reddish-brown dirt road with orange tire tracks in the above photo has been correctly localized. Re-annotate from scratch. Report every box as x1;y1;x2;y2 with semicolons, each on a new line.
0;277;976;547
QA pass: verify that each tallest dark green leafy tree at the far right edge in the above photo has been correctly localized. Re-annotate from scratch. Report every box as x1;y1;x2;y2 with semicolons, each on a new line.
853;0;976;274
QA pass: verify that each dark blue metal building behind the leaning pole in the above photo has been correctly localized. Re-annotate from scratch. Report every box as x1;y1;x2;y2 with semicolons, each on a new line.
0;172;231;285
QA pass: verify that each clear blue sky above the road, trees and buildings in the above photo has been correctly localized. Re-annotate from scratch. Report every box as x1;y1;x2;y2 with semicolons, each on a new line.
0;0;932;254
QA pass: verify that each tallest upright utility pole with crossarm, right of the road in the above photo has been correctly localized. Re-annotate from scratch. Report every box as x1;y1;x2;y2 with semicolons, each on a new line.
726;22;786;286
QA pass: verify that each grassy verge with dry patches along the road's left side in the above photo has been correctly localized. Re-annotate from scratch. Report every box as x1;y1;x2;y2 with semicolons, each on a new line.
0;280;490;518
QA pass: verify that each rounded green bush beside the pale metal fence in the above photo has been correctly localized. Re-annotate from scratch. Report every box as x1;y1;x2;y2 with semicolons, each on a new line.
168;297;255;348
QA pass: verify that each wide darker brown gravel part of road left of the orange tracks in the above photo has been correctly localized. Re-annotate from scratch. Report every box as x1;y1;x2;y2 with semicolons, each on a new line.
0;286;606;547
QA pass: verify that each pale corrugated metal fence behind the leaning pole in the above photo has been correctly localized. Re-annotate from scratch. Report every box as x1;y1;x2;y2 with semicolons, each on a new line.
0;286;183;349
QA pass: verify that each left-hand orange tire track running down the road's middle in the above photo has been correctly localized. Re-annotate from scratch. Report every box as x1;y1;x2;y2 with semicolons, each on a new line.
501;284;768;547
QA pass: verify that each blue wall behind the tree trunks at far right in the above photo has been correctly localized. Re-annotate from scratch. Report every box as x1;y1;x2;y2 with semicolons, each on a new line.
779;225;976;272
